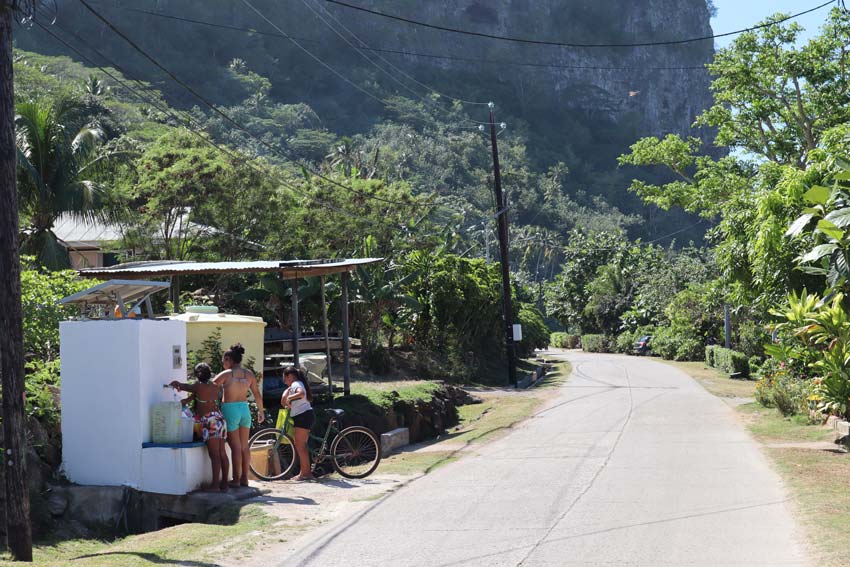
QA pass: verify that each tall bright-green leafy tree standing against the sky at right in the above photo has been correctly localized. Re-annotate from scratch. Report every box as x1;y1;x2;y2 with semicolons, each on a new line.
620;9;850;313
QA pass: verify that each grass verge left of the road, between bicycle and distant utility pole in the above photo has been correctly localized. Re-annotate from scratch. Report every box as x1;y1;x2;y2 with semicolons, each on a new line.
381;362;572;475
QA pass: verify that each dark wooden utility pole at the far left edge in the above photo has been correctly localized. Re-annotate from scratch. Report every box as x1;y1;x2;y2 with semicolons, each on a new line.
0;0;32;561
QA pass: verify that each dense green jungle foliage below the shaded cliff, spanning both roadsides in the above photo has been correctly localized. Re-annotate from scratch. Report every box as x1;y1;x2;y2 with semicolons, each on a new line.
16;4;850;432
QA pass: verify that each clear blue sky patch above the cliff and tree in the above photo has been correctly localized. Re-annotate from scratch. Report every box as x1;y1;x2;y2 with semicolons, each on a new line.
711;0;834;47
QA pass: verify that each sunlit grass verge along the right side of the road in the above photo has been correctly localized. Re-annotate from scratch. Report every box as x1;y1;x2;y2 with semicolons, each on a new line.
670;362;850;565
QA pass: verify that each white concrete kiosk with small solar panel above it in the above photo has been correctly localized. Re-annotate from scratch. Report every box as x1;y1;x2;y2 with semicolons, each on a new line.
59;304;217;495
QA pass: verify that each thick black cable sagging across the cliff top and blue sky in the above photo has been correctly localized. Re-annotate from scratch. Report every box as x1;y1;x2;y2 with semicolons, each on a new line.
325;0;835;47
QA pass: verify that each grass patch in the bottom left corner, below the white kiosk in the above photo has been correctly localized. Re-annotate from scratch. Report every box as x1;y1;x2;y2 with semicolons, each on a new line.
0;504;280;567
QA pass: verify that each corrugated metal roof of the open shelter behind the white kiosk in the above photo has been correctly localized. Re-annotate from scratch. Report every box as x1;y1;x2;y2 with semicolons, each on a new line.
80;258;383;278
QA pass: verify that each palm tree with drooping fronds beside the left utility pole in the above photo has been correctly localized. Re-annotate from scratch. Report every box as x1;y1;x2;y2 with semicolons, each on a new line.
15;99;118;269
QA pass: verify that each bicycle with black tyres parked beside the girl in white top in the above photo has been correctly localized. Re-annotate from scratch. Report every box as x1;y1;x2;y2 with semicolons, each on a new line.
248;409;381;480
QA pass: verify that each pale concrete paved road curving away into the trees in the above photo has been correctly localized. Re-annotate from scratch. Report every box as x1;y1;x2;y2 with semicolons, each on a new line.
285;353;807;567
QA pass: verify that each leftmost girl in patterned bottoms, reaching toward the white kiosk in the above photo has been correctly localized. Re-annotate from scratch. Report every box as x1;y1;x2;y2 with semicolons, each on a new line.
171;362;230;492
